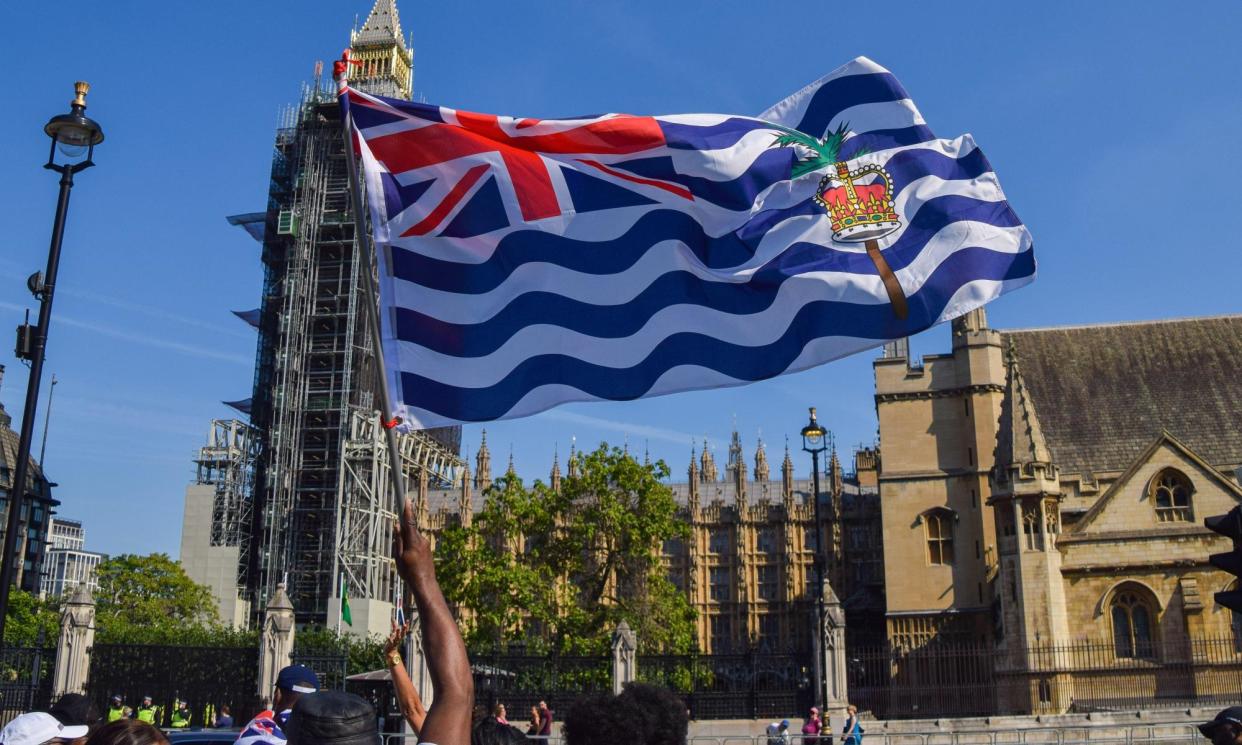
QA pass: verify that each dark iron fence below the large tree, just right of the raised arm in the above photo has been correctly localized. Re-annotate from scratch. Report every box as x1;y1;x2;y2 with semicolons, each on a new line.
469;647;612;724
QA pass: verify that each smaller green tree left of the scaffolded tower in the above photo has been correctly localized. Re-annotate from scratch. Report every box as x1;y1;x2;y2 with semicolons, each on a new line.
94;554;222;643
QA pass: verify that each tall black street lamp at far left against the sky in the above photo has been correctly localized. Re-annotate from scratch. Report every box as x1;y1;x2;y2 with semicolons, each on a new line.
0;81;103;647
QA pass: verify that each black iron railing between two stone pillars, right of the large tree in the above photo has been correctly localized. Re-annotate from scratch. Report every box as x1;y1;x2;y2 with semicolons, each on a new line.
637;651;815;719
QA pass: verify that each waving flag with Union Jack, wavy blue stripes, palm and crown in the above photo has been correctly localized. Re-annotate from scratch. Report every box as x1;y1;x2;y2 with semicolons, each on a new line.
340;57;1035;428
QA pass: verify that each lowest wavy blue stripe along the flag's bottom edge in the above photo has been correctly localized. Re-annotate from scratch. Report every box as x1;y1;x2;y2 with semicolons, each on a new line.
401;245;1035;422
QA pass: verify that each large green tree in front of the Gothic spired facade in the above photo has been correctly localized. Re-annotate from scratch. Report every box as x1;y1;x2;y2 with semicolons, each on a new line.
436;443;694;653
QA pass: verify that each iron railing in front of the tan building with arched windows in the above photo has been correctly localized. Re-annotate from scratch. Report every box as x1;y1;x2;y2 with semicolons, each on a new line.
847;637;1242;719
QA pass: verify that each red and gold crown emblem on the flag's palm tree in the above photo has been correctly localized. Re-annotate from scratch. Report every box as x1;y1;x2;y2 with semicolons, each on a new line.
815;161;902;243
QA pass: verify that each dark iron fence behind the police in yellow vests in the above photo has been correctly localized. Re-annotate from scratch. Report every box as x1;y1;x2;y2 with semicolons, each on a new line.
87;644;262;726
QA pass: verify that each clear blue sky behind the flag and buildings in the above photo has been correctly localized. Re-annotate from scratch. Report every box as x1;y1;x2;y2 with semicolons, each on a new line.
0;0;1242;555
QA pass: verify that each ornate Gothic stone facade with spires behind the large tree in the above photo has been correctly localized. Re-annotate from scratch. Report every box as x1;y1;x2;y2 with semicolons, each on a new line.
427;432;884;653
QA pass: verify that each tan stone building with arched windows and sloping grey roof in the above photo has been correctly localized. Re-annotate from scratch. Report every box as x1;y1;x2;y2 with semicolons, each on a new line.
874;310;1242;711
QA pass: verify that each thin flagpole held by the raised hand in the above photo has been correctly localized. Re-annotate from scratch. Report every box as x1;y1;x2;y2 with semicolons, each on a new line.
338;62;405;523
